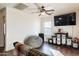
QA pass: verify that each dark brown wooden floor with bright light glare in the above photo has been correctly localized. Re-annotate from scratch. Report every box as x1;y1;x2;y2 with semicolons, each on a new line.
0;43;79;56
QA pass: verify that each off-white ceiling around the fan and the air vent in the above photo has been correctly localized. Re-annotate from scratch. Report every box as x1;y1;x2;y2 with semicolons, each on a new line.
0;3;79;13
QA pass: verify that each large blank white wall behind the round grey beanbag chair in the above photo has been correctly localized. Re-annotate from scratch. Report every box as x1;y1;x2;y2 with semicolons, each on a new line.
6;8;40;50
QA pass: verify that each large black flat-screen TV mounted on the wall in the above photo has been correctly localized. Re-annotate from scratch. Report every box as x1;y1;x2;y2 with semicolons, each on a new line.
54;12;76;26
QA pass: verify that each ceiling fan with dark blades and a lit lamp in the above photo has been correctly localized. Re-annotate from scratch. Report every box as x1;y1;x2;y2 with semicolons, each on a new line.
33;3;55;16
